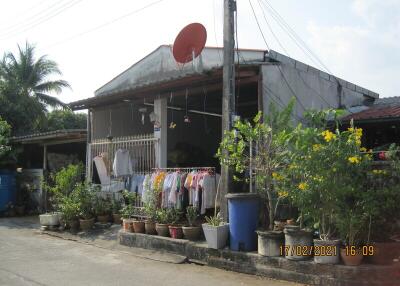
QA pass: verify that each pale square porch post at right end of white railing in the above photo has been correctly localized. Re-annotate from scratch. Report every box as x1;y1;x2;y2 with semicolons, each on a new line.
154;98;168;168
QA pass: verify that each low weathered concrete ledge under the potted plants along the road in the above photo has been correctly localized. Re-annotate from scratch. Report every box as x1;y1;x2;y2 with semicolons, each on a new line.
118;230;400;286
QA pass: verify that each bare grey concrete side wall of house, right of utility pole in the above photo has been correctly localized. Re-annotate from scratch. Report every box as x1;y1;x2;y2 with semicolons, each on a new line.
261;61;372;118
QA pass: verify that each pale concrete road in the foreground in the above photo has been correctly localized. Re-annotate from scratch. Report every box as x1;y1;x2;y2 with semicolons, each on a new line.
0;218;299;286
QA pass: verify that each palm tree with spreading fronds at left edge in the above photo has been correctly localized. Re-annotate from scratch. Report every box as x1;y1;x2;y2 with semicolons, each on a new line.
0;43;70;134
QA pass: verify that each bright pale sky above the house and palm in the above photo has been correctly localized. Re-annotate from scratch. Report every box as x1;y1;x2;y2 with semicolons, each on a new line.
0;0;400;102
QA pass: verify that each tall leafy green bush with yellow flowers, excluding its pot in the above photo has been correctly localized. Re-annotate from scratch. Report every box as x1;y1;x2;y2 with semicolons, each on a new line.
279;111;371;239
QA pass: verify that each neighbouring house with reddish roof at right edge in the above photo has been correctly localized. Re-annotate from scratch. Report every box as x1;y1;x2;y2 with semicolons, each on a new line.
342;97;400;150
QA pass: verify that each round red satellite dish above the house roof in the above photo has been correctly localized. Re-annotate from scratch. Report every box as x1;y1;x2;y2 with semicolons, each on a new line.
172;23;207;64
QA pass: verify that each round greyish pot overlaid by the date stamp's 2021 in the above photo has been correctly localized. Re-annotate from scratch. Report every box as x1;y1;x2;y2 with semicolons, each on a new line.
314;239;340;264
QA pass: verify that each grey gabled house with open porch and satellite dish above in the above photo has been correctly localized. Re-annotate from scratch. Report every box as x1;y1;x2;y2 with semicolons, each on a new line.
70;45;379;182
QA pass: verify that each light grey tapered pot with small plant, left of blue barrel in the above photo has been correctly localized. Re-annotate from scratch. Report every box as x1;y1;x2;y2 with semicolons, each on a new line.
202;213;229;249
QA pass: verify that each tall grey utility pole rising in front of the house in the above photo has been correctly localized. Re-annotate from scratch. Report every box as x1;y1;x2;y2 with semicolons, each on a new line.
220;0;236;220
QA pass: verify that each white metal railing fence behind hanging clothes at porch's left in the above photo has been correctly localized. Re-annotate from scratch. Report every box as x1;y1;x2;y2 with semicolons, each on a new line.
86;134;158;181
